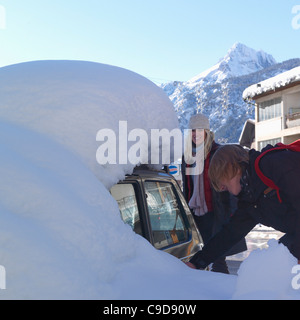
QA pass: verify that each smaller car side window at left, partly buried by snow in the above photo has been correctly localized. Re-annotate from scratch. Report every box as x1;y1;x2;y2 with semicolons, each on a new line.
110;183;143;236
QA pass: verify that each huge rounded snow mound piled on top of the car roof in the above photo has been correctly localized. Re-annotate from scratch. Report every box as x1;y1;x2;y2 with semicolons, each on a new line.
0;61;178;187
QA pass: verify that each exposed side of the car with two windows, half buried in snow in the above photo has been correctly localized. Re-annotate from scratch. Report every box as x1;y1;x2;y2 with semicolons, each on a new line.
110;169;203;261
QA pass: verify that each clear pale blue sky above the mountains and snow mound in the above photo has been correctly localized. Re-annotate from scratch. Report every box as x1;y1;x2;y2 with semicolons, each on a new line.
0;0;300;82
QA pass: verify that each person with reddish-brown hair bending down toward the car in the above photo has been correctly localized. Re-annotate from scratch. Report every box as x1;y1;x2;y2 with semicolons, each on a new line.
187;145;300;269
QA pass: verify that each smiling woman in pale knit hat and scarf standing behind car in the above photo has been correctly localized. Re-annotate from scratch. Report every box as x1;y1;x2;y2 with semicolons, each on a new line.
182;114;247;274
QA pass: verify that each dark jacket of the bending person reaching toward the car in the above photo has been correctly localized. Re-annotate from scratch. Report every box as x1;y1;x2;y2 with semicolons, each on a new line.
191;146;300;268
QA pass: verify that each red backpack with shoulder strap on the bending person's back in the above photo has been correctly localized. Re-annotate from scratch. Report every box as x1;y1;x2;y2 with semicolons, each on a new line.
255;139;300;203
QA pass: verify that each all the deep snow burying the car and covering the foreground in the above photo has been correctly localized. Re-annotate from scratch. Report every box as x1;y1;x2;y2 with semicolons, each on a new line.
0;61;300;300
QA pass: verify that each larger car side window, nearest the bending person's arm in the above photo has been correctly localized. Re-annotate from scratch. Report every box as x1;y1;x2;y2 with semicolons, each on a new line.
145;181;189;249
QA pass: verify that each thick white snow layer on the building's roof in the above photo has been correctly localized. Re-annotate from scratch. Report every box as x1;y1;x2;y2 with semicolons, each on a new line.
243;67;300;100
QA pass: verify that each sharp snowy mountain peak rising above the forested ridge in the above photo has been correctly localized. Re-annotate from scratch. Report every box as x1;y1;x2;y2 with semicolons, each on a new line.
188;42;276;85
